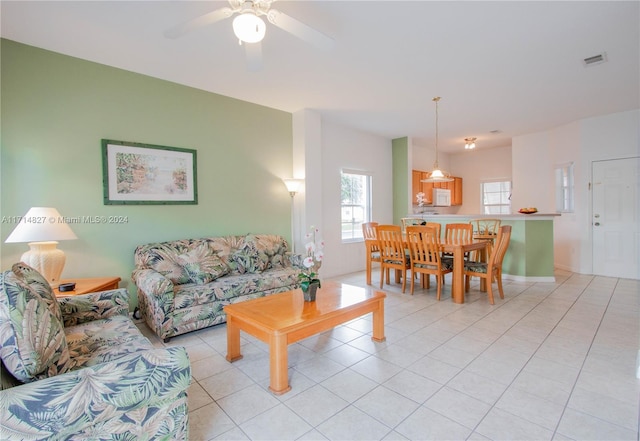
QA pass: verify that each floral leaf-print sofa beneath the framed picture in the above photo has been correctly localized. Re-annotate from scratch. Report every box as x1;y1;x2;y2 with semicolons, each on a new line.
131;234;303;341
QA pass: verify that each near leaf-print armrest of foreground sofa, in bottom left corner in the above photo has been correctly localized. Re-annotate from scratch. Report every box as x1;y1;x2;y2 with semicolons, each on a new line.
0;347;191;440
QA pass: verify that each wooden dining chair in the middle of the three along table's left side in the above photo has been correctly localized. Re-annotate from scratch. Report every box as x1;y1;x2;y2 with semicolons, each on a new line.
376;225;411;293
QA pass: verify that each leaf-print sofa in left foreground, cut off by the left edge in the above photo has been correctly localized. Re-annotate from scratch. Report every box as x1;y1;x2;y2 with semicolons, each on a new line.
0;263;191;440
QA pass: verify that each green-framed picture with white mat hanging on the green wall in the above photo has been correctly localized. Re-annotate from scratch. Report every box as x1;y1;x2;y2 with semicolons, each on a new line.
102;139;198;205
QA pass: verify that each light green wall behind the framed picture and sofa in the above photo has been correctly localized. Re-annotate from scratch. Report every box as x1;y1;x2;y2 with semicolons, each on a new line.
0;39;292;304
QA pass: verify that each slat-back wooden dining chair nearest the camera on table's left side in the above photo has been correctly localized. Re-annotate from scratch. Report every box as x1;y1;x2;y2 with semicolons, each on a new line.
406;224;453;300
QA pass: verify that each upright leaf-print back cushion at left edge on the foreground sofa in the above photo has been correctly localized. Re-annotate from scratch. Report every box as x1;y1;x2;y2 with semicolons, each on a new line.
0;271;70;382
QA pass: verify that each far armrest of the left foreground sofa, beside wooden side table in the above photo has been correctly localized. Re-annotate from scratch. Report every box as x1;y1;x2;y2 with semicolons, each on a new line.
58;288;129;326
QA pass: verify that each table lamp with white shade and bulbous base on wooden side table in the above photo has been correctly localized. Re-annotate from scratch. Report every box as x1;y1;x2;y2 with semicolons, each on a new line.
5;207;78;288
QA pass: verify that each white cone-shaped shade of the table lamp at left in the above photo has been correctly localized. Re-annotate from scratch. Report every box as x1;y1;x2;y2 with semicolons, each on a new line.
5;207;78;243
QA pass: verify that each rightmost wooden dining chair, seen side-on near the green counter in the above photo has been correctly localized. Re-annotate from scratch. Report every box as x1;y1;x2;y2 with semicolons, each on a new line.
464;225;511;305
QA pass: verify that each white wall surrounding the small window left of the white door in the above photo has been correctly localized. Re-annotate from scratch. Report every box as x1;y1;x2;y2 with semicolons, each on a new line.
512;109;640;274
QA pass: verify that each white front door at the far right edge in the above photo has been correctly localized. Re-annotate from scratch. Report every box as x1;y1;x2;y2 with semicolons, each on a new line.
591;158;640;279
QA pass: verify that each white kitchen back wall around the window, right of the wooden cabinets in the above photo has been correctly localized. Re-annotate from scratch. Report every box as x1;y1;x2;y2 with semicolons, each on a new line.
449;147;511;214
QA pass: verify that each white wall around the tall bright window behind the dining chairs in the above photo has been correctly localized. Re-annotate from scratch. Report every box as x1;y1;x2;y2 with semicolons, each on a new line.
293;110;393;278
